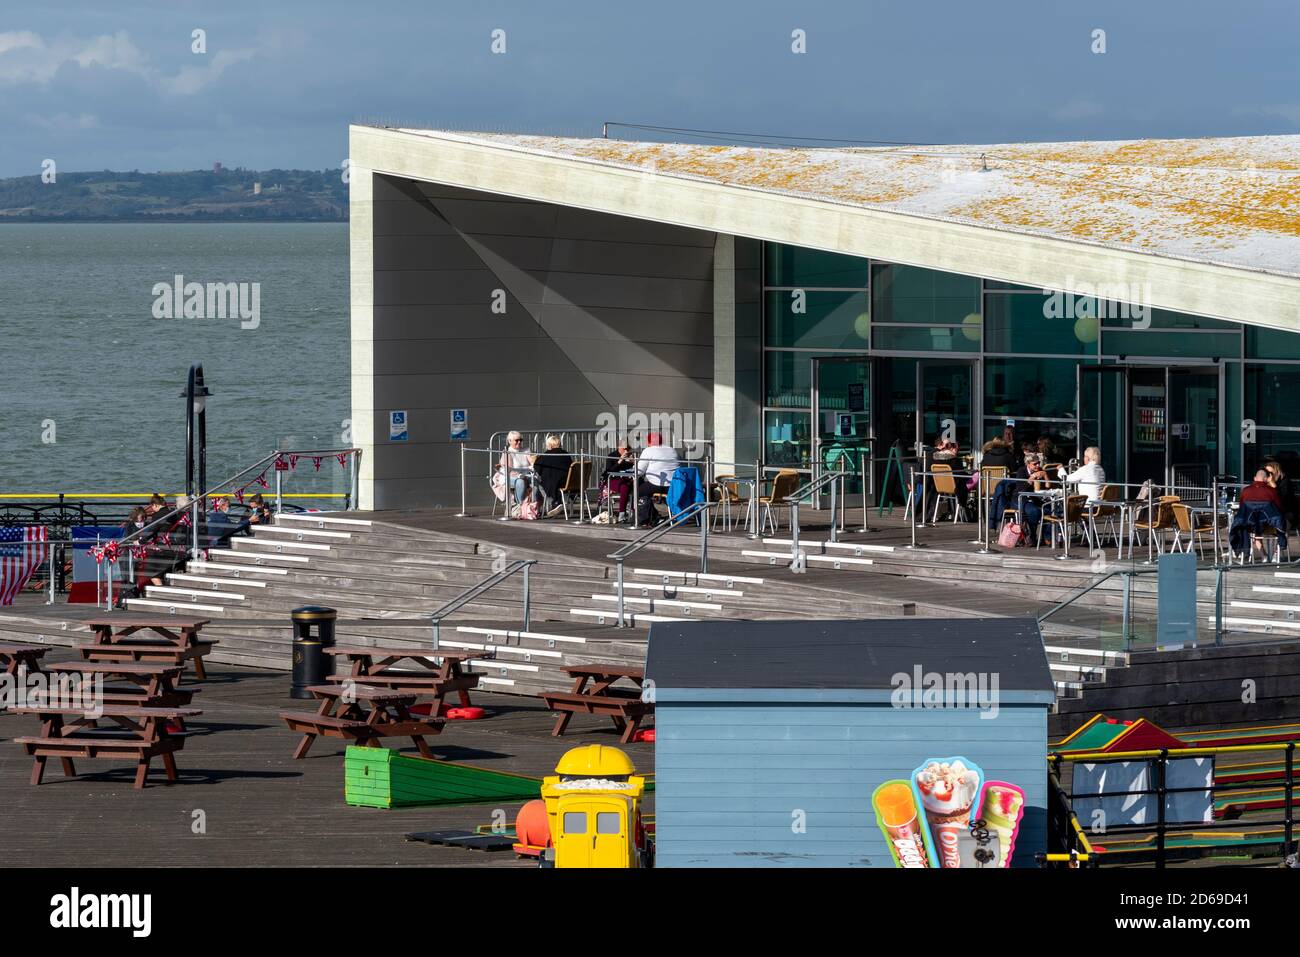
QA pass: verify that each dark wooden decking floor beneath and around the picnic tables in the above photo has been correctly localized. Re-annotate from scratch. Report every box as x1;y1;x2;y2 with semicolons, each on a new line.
0;649;654;867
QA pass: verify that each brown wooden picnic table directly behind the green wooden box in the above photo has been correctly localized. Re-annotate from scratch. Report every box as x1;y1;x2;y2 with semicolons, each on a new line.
280;679;445;759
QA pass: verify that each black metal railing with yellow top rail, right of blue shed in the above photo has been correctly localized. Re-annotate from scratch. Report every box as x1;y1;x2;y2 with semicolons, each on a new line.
1048;740;1296;867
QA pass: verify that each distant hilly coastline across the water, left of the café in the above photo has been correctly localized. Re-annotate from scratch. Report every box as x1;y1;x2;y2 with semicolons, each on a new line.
0;165;347;225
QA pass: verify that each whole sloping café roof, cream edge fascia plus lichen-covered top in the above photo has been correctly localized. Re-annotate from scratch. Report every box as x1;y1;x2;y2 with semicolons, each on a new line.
350;126;1300;332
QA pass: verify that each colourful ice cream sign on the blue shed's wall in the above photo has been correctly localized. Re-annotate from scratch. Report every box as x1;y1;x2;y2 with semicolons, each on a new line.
871;757;1024;867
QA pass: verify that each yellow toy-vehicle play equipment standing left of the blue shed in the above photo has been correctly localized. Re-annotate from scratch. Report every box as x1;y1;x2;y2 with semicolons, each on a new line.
538;744;654;867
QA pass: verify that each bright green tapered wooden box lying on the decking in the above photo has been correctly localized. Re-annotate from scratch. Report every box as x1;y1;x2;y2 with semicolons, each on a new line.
343;745;542;807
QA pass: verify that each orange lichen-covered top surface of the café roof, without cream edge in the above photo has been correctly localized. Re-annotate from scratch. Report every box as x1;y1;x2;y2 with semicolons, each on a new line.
390;130;1300;276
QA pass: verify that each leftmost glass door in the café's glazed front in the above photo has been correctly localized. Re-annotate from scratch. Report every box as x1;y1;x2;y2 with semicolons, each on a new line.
813;356;872;495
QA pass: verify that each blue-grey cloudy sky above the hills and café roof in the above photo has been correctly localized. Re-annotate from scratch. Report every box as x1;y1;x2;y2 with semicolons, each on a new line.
0;0;1300;177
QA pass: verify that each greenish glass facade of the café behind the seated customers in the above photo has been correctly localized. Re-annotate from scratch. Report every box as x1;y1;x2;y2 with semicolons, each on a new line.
762;243;1300;481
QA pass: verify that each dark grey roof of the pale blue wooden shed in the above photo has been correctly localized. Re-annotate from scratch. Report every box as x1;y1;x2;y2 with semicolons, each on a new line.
646;618;1054;694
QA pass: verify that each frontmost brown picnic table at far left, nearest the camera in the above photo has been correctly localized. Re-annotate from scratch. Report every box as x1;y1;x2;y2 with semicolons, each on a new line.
13;705;203;789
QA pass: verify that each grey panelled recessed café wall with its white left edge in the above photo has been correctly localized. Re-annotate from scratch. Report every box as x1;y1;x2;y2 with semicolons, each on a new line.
352;169;715;508
